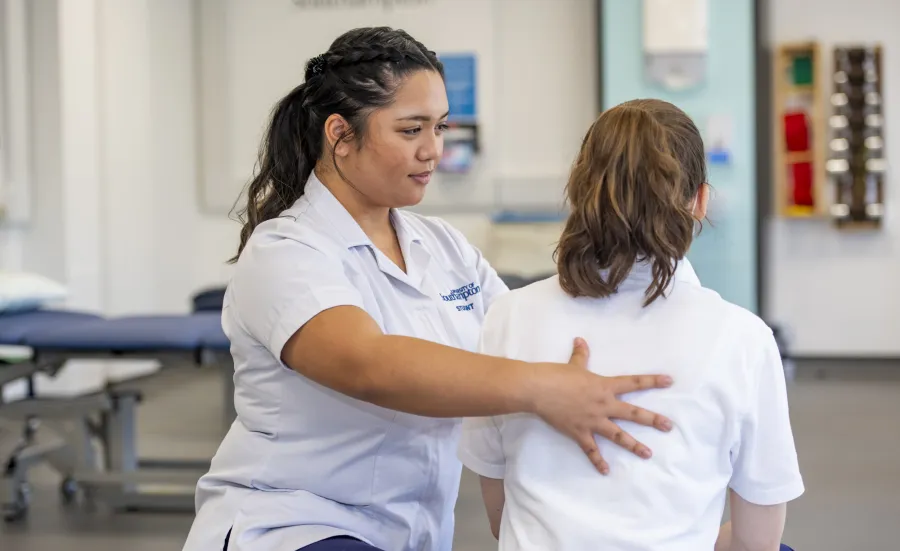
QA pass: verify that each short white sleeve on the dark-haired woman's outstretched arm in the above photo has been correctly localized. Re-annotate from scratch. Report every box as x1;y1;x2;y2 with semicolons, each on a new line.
231;231;364;359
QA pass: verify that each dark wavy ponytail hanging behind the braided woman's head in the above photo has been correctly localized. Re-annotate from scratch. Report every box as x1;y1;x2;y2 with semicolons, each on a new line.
229;83;321;263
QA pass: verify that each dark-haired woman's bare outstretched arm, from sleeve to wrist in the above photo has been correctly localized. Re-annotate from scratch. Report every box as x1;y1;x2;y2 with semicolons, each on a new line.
281;307;541;417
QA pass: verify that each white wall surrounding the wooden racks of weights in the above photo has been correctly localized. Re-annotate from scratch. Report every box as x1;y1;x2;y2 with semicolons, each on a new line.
766;0;900;357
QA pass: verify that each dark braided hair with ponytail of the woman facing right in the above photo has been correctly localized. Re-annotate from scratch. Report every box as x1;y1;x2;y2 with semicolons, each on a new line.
230;27;444;262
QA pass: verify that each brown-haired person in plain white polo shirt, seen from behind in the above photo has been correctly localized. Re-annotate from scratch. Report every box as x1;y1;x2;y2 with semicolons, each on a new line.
460;100;804;551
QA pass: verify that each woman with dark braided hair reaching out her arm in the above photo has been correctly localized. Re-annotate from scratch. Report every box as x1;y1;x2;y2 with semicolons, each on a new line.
184;27;671;551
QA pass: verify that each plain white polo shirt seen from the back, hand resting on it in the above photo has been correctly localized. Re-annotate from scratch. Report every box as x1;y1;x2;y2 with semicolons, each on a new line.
460;260;804;551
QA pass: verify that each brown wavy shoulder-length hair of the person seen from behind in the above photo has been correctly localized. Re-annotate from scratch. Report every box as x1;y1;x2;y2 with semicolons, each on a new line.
555;99;706;305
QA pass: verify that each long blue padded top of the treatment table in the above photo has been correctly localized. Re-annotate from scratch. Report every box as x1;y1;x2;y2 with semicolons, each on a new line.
25;312;224;352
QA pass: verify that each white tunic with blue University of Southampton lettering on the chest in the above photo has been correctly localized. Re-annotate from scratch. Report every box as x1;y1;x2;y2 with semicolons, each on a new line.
184;176;507;551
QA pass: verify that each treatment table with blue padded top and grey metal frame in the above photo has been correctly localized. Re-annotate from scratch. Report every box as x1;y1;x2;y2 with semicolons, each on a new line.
0;309;234;521
